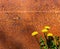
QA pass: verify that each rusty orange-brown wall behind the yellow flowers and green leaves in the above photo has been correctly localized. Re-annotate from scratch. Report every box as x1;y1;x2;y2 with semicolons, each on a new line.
0;0;60;49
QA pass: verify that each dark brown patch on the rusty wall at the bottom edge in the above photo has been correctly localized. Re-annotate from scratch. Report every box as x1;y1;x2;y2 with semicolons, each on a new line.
5;40;26;49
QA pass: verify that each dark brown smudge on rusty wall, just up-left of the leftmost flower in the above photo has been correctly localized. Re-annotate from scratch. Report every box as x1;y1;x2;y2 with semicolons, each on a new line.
20;25;36;35
